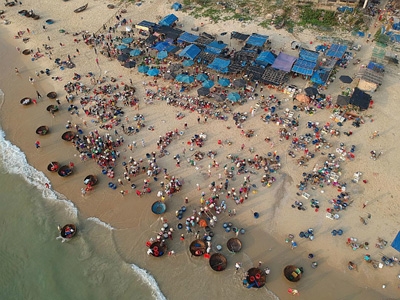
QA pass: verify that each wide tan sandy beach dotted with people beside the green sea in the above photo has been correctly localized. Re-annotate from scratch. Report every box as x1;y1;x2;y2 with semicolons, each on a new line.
0;0;400;299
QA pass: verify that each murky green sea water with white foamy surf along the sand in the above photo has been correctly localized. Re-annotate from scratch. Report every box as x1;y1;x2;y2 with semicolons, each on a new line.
0;131;165;300
